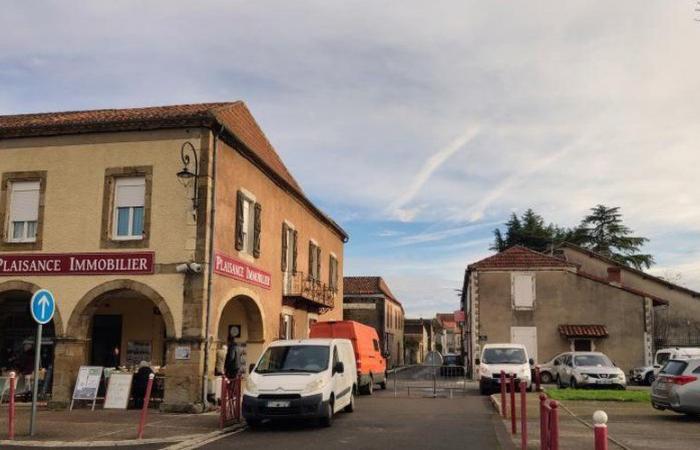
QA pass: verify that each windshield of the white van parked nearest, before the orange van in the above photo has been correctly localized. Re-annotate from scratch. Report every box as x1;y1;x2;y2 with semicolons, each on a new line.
255;345;329;373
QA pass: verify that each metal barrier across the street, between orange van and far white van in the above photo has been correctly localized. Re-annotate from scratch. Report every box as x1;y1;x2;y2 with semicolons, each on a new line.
388;365;467;398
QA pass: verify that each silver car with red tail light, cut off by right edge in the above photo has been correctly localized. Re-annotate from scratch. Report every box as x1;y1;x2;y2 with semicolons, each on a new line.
651;358;700;415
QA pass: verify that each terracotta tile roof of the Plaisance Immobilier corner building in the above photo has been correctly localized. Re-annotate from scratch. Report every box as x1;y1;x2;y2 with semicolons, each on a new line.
0;101;347;243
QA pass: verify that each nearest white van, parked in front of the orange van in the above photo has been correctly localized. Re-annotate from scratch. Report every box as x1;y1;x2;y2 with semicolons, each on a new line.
243;339;357;427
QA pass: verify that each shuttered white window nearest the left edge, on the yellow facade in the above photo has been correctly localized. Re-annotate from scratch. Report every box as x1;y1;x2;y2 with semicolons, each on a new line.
5;181;40;242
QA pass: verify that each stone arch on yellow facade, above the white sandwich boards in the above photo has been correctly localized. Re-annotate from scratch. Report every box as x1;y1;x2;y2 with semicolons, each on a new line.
66;279;176;339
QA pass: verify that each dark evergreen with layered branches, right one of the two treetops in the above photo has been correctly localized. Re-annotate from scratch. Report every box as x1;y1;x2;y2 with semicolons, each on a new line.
576;205;654;270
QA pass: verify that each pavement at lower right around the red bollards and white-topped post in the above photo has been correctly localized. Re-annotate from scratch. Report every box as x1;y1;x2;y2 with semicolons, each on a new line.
491;392;700;450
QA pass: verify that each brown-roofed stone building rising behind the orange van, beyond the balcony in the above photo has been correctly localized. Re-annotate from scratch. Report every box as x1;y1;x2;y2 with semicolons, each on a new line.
343;277;404;367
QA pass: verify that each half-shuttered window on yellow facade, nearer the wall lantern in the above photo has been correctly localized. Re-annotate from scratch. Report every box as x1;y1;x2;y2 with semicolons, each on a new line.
112;177;146;240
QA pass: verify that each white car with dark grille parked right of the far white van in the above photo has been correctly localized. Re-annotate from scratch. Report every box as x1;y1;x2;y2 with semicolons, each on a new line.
554;352;627;389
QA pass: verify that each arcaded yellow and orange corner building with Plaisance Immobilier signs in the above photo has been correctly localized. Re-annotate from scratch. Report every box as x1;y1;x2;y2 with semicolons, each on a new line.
0;102;347;411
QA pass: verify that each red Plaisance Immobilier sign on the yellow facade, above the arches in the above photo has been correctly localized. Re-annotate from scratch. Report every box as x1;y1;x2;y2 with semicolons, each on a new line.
0;252;155;277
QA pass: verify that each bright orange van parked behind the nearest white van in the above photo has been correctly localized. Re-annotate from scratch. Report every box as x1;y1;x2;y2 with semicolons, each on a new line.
309;320;386;395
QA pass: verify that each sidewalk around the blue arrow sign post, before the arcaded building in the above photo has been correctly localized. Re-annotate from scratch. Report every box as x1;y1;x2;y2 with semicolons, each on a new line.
0;404;241;447
